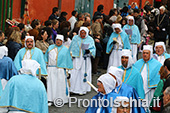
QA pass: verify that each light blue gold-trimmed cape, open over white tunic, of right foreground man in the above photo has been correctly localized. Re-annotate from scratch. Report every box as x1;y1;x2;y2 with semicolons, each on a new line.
134;58;162;88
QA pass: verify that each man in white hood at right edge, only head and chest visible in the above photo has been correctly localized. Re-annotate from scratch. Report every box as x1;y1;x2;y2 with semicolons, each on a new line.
153;42;170;65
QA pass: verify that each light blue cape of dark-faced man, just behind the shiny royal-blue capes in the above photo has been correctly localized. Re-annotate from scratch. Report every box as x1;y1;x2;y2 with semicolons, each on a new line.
118;66;145;99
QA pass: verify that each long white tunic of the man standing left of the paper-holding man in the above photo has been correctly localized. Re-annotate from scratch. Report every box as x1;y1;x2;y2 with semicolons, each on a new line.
47;48;69;103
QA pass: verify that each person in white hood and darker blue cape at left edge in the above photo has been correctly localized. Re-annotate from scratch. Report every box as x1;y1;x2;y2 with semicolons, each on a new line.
0;46;18;96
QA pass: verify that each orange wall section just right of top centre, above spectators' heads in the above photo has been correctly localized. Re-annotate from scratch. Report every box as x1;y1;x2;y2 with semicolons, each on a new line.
93;0;114;15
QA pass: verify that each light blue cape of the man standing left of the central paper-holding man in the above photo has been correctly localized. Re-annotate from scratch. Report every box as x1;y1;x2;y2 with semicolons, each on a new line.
44;44;73;69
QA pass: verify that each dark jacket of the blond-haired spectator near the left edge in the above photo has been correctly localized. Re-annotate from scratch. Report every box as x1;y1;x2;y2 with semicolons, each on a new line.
6;41;22;61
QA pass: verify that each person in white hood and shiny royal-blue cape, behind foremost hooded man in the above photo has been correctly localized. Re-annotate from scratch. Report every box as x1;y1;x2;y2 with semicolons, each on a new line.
107;66;145;113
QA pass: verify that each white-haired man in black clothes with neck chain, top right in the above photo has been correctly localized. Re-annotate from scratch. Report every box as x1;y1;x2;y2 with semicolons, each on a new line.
154;6;169;44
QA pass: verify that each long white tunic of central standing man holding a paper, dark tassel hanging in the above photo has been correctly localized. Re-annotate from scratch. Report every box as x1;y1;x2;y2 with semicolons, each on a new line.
70;51;92;94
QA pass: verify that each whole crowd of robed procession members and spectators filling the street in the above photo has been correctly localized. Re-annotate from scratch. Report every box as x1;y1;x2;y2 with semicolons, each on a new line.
0;1;170;113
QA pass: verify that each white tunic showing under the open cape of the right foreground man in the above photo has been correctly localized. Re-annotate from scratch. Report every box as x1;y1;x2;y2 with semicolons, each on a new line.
141;64;155;111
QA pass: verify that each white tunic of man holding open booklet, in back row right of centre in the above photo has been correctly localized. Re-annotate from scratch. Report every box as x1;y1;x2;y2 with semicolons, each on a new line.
107;36;123;69
